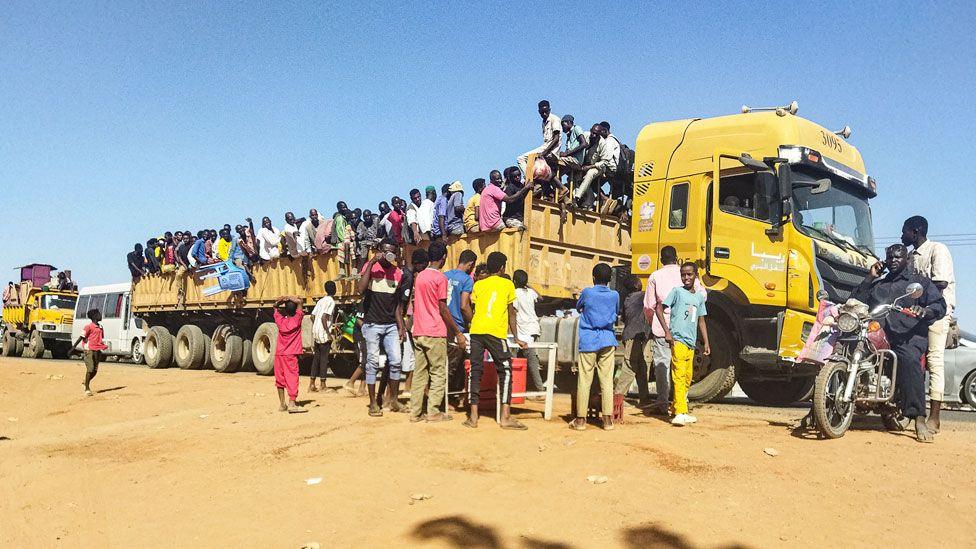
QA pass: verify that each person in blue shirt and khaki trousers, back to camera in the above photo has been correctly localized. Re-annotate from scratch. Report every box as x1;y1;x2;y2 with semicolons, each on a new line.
569;263;620;431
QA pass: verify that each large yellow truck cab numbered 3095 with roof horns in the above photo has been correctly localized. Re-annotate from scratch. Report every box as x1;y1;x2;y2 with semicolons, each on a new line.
631;103;877;404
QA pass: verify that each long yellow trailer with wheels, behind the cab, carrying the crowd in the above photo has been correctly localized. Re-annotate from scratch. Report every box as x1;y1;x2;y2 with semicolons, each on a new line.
132;201;630;375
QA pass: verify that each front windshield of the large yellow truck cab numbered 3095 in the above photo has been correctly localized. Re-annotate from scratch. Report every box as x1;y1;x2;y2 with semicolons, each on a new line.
793;167;874;255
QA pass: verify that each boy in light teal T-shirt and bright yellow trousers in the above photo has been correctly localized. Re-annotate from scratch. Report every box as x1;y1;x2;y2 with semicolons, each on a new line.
655;261;712;427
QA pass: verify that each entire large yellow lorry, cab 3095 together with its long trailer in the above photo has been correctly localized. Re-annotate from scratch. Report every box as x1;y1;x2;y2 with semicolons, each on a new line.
132;104;877;404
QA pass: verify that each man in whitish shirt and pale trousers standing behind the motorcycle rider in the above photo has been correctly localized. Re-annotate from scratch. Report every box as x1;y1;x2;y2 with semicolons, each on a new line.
901;215;956;433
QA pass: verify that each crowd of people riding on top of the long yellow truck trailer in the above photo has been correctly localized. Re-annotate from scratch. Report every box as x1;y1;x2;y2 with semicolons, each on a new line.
126;101;633;279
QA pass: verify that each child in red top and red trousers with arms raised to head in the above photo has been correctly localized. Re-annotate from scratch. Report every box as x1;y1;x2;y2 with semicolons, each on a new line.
274;296;308;414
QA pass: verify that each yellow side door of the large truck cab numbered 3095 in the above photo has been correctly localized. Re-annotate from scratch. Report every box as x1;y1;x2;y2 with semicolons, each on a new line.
708;153;787;306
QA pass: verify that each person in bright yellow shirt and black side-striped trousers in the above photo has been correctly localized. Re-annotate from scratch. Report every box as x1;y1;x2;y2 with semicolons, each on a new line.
463;252;528;431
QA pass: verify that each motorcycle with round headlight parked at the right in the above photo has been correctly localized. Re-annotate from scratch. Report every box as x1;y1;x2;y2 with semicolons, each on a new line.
812;283;923;438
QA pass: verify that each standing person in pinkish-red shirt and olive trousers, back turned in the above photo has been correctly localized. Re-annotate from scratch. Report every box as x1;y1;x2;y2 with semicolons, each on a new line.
410;240;468;423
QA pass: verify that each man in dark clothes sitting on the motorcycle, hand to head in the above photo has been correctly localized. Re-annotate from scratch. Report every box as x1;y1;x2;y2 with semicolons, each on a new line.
851;244;946;442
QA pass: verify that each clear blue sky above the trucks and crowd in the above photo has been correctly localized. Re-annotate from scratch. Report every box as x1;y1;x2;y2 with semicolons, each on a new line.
0;2;976;322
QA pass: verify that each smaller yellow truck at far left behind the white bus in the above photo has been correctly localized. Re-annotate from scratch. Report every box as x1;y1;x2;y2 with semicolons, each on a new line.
0;265;78;358
